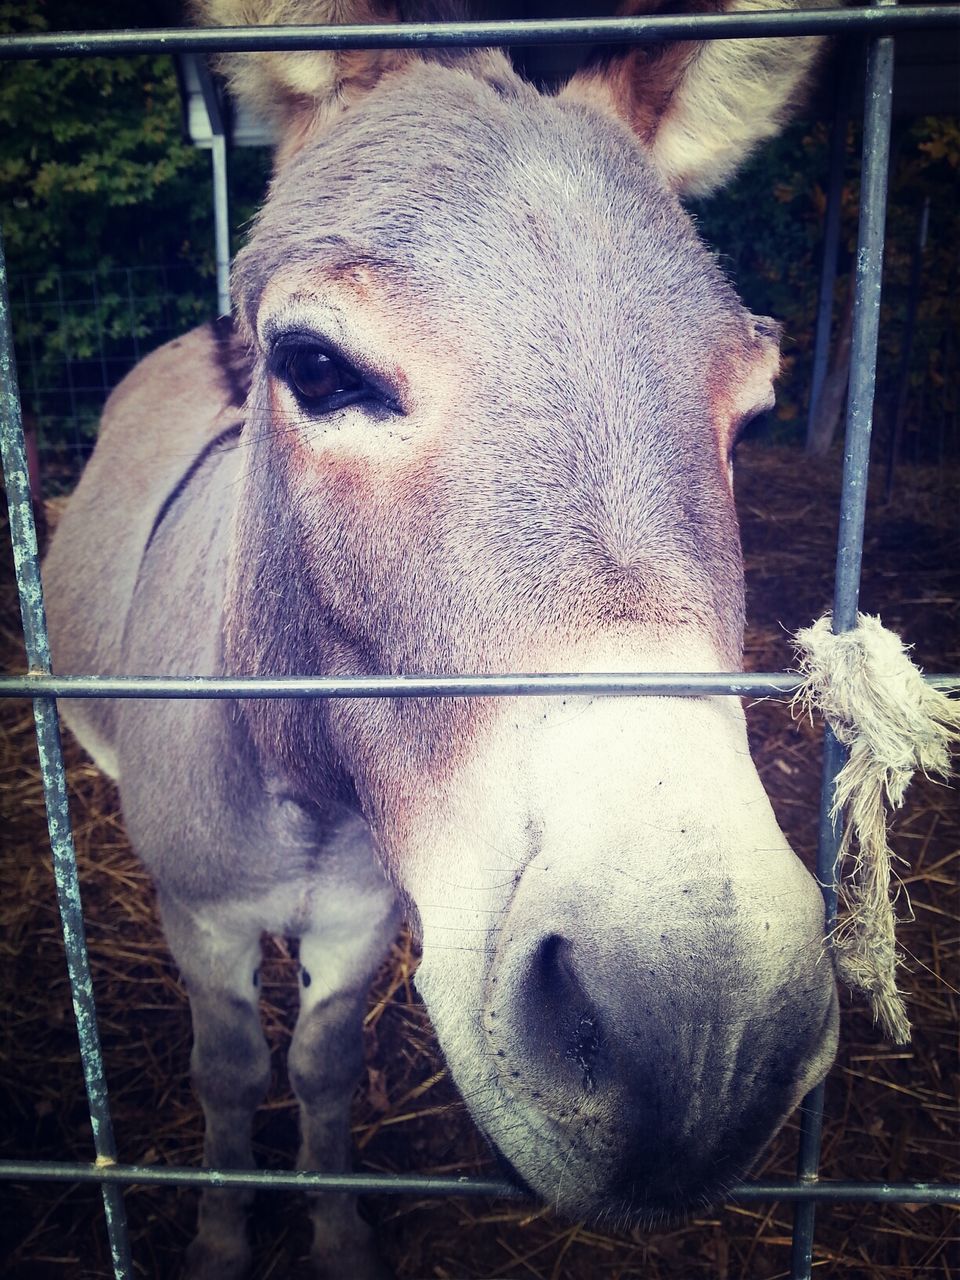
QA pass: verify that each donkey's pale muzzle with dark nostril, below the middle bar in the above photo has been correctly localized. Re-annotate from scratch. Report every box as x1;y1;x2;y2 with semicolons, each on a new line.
401;699;837;1226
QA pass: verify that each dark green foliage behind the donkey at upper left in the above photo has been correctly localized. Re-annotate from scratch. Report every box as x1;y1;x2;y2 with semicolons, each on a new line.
0;0;264;471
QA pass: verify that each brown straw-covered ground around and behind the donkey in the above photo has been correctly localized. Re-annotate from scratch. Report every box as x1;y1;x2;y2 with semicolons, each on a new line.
0;447;960;1280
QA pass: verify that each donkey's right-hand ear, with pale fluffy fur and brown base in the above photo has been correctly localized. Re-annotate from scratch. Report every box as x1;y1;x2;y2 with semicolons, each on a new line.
563;0;828;196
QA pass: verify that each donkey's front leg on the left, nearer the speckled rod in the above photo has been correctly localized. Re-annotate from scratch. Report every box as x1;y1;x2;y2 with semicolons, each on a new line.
161;899;270;1280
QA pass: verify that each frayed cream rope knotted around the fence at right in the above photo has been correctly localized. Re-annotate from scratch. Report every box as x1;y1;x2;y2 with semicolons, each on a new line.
792;613;960;1044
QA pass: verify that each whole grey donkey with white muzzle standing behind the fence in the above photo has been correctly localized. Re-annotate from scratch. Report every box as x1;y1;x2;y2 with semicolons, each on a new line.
45;0;837;1280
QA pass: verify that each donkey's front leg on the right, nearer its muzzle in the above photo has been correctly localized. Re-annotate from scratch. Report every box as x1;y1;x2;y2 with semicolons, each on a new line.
288;891;397;1280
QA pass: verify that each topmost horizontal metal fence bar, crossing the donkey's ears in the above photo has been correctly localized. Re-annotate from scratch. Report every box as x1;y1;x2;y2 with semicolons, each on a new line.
0;4;960;59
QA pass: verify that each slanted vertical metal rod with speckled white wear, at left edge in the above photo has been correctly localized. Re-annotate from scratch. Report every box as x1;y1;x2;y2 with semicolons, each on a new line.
0;232;133;1280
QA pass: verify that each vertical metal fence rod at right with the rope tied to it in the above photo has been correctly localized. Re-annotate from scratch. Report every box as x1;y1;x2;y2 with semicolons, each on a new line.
791;12;893;1280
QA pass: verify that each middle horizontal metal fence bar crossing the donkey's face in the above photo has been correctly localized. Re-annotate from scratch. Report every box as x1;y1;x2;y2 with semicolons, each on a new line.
0;671;960;698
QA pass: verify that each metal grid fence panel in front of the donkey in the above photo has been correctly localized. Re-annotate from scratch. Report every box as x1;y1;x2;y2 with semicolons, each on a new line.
0;5;960;1280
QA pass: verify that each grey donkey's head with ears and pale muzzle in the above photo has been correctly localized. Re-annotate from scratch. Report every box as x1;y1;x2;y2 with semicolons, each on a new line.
209;0;836;1221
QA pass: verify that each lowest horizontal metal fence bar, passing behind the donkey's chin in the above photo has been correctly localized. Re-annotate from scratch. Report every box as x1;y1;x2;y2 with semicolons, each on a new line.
0;1160;960;1204
